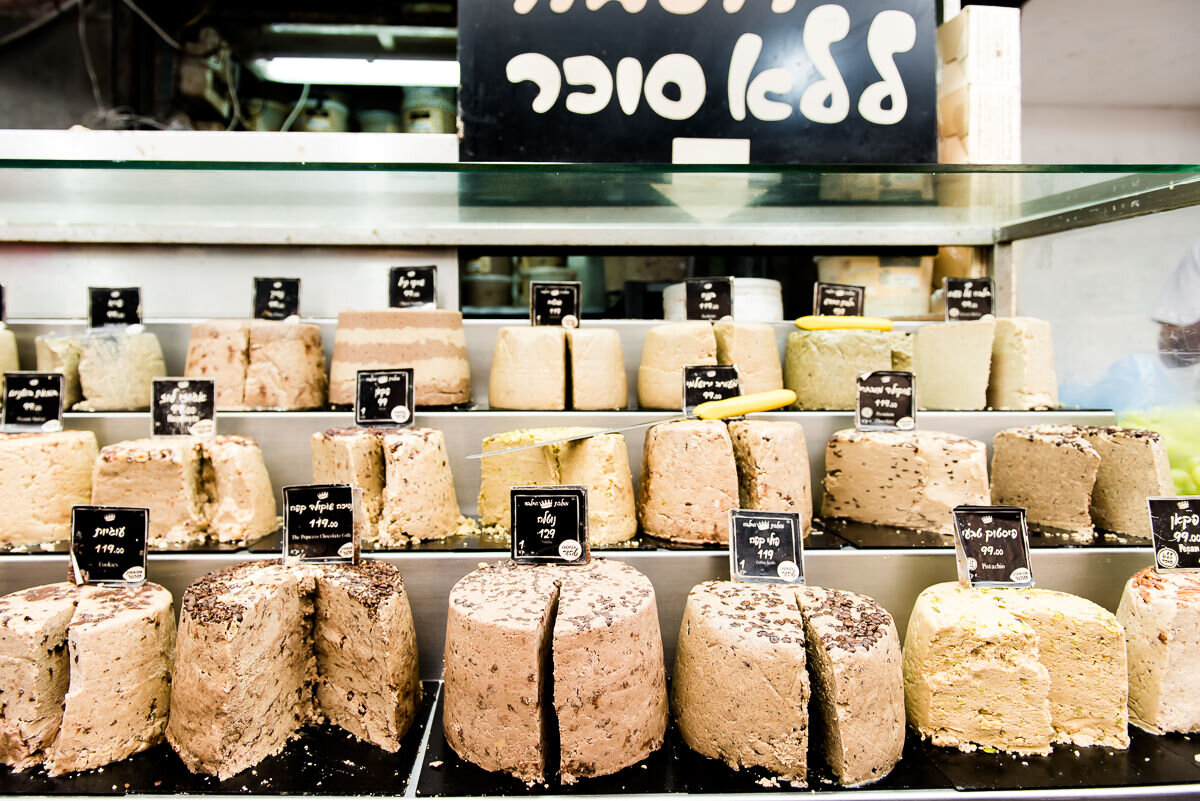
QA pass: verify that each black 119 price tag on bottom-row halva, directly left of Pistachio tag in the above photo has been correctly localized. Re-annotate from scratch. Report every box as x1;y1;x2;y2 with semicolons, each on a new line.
730;508;804;584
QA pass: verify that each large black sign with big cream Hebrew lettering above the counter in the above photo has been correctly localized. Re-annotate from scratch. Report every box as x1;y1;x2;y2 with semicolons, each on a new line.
458;0;937;163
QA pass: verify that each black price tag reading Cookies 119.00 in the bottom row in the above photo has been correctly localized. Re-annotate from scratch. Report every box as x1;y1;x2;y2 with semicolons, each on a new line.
71;506;150;584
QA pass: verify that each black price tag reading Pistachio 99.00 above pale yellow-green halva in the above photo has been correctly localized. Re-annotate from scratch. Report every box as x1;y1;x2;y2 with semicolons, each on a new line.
954;506;1033;586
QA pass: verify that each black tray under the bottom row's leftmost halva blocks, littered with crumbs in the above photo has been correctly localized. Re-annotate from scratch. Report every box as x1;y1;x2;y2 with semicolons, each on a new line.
0;681;442;795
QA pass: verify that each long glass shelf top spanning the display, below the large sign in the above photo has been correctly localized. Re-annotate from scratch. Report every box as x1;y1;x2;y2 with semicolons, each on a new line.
0;134;1200;247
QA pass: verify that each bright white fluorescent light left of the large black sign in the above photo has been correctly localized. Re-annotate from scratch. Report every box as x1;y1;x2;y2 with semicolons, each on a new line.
250;56;458;88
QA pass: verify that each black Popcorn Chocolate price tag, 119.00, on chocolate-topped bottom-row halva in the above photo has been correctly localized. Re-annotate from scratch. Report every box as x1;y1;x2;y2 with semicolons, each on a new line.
283;484;362;564
